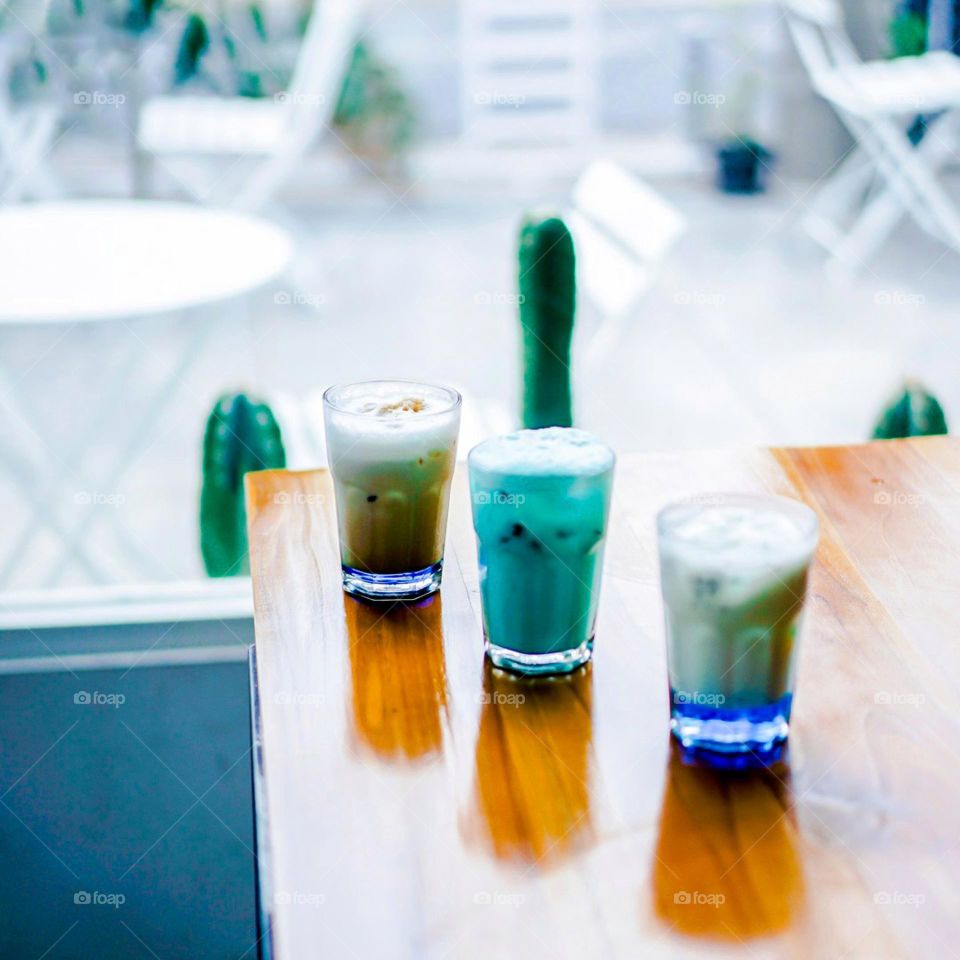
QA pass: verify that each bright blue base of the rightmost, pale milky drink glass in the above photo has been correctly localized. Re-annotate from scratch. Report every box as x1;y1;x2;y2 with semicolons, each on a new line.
670;690;793;754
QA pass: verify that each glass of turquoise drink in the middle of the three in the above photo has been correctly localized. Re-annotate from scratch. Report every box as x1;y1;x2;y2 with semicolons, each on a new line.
468;427;614;674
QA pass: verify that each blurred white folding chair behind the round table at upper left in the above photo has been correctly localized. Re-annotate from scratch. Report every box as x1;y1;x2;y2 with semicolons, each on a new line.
138;0;363;210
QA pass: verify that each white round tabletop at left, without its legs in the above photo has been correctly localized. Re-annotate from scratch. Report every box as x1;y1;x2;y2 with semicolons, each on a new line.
0;200;293;324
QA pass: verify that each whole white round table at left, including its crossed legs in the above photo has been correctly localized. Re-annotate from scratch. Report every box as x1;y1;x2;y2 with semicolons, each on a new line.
0;200;293;586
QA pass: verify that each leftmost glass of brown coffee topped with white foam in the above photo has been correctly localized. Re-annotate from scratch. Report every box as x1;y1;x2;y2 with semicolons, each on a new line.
324;380;460;600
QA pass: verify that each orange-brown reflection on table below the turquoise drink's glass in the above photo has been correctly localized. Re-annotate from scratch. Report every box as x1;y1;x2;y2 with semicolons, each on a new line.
471;661;593;864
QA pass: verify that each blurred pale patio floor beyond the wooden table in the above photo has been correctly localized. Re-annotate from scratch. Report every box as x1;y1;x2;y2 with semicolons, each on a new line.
0;176;960;586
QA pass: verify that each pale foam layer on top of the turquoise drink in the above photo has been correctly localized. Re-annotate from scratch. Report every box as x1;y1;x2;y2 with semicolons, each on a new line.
470;427;614;477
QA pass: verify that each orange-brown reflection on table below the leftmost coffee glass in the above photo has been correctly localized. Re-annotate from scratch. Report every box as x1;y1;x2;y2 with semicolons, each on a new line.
343;594;447;763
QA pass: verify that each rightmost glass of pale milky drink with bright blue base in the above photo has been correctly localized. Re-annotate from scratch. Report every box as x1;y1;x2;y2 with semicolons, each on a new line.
657;494;819;754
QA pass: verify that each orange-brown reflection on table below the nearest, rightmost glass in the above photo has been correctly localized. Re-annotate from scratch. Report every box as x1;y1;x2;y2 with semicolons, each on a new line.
653;738;804;940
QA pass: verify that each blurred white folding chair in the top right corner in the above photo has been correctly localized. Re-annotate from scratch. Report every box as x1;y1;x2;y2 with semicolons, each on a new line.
782;0;960;267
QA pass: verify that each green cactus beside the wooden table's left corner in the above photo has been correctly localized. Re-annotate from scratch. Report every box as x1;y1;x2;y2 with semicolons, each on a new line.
200;393;287;577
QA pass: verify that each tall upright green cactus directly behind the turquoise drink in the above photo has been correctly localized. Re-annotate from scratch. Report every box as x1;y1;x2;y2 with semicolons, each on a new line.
519;216;577;428
